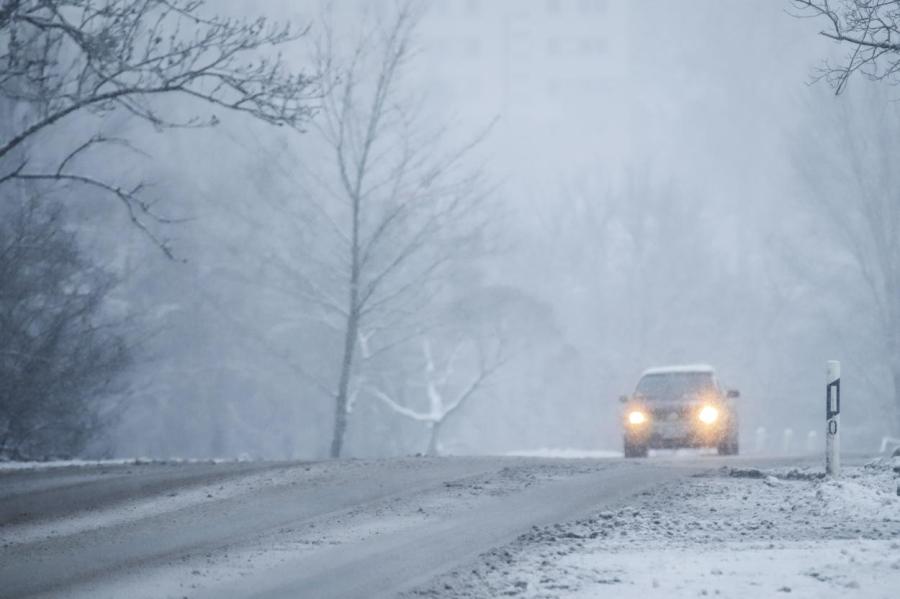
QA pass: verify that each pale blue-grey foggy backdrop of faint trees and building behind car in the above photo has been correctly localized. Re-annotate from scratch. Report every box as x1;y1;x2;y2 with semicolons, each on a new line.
31;0;896;458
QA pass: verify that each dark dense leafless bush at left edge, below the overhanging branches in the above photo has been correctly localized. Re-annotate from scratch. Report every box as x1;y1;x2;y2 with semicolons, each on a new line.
0;199;129;459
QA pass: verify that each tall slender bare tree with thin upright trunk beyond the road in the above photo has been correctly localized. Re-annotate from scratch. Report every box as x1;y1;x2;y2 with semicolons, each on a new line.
268;3;485;457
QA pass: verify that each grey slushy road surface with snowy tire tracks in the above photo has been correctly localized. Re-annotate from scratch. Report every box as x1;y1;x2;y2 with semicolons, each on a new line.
0;456;812;599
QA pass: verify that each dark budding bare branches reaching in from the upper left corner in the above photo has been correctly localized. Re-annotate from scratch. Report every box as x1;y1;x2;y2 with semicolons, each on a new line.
0;0;313;253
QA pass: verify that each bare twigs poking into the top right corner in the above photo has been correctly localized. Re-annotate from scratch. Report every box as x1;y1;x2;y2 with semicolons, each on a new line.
793;0;900;94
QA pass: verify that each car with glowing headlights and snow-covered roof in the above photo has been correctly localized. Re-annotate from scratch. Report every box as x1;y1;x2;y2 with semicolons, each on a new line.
620;364;740;458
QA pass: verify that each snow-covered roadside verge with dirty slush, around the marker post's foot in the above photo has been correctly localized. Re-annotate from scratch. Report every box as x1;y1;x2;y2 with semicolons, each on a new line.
410;460;900;599
